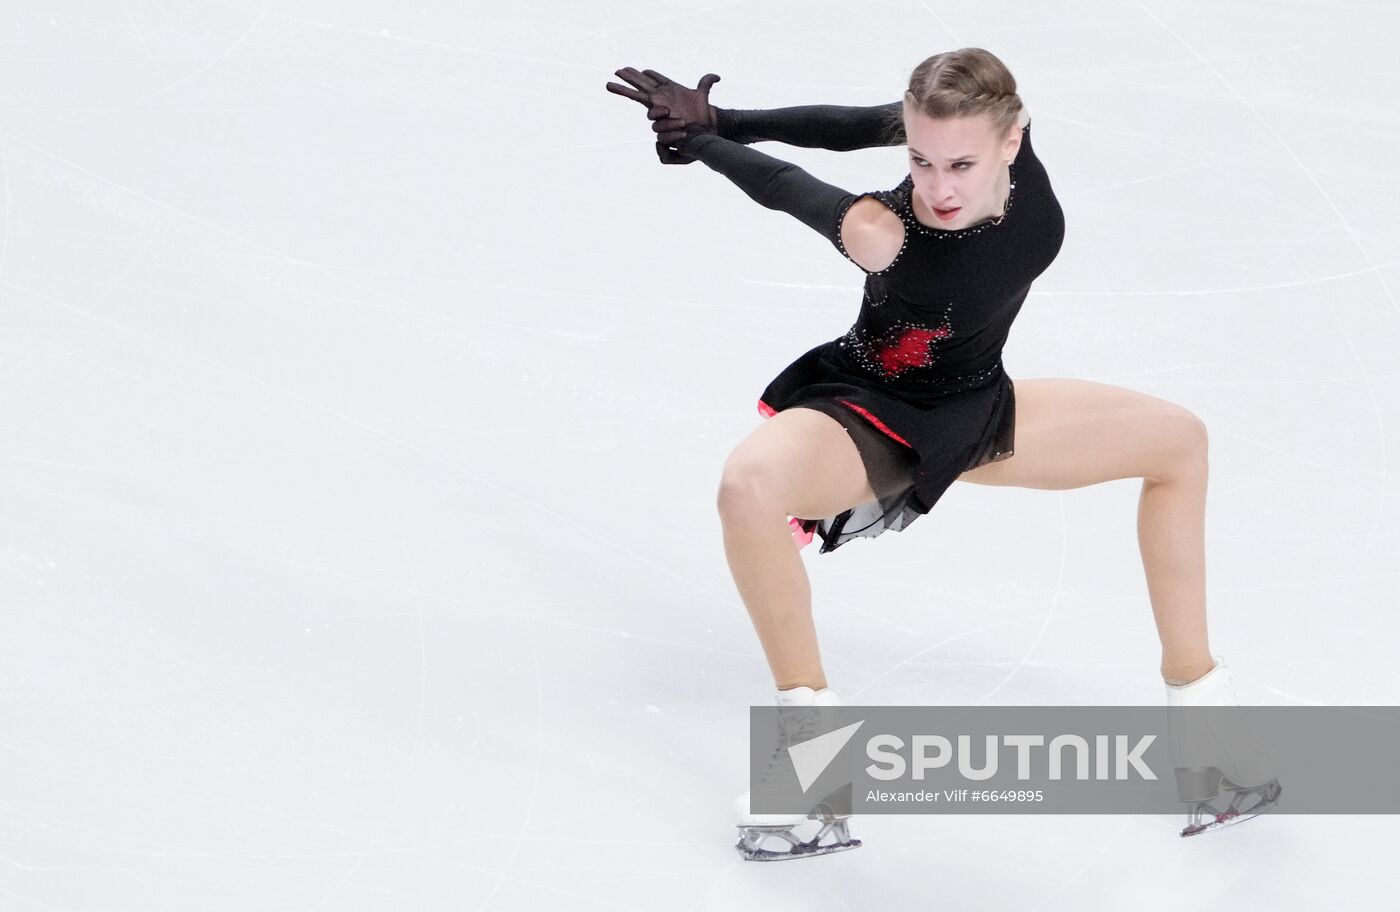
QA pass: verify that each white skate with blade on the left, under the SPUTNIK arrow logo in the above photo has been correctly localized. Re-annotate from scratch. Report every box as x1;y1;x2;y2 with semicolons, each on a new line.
734;686;861;862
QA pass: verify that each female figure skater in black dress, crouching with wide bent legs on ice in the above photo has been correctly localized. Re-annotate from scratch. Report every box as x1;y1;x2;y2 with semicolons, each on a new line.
606;48;1277;860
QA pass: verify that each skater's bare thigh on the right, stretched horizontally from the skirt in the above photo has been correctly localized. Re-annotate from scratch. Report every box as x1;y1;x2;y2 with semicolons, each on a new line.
958;378;1205;490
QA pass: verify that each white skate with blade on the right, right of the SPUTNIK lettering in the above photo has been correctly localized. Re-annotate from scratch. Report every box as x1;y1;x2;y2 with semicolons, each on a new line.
1166;656;1282;836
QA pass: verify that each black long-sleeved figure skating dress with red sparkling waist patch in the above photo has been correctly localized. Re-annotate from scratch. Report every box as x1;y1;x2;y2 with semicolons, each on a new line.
680;102;1064;553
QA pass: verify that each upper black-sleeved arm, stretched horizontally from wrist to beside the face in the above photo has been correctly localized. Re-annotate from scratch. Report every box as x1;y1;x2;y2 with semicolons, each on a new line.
711;101;907;151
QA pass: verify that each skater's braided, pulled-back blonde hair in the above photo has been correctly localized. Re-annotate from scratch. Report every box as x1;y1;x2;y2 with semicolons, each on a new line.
890;48;1025;141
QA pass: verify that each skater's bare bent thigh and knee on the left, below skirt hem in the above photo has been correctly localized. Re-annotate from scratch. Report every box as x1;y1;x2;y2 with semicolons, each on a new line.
721;406;875;520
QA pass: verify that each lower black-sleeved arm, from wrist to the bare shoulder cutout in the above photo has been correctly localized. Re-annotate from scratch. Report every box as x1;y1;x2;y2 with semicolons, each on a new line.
678;133;864;269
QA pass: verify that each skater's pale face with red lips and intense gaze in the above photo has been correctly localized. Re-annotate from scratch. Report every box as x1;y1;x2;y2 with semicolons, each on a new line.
904;102;1021;230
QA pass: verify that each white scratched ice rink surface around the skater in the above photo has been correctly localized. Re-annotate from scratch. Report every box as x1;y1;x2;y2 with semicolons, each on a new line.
0;0;1400;912
